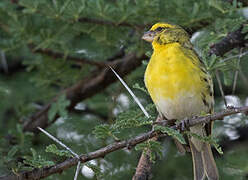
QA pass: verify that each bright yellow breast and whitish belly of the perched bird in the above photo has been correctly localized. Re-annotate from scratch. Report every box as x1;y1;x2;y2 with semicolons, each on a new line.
145;43;205;119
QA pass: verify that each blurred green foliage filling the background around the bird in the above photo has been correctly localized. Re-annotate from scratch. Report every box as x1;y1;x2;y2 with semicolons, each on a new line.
0;0;248;180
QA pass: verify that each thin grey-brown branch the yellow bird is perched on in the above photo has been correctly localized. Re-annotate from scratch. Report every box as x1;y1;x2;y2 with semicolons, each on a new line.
0;106;248;180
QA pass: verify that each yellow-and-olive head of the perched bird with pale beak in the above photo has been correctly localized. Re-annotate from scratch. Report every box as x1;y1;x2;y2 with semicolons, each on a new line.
142;23;189;45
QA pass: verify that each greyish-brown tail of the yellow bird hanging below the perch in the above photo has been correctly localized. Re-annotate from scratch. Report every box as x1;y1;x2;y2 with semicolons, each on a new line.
189;140;219;180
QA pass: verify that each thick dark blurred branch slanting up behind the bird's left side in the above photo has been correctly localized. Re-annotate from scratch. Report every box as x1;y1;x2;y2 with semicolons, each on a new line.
24;53;147;132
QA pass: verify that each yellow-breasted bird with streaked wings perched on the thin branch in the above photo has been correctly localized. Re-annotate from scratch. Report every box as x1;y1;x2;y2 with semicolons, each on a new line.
142;23;219;180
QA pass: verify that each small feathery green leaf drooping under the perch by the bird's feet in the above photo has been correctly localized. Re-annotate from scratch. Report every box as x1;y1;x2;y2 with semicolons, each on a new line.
154;125;186;144
